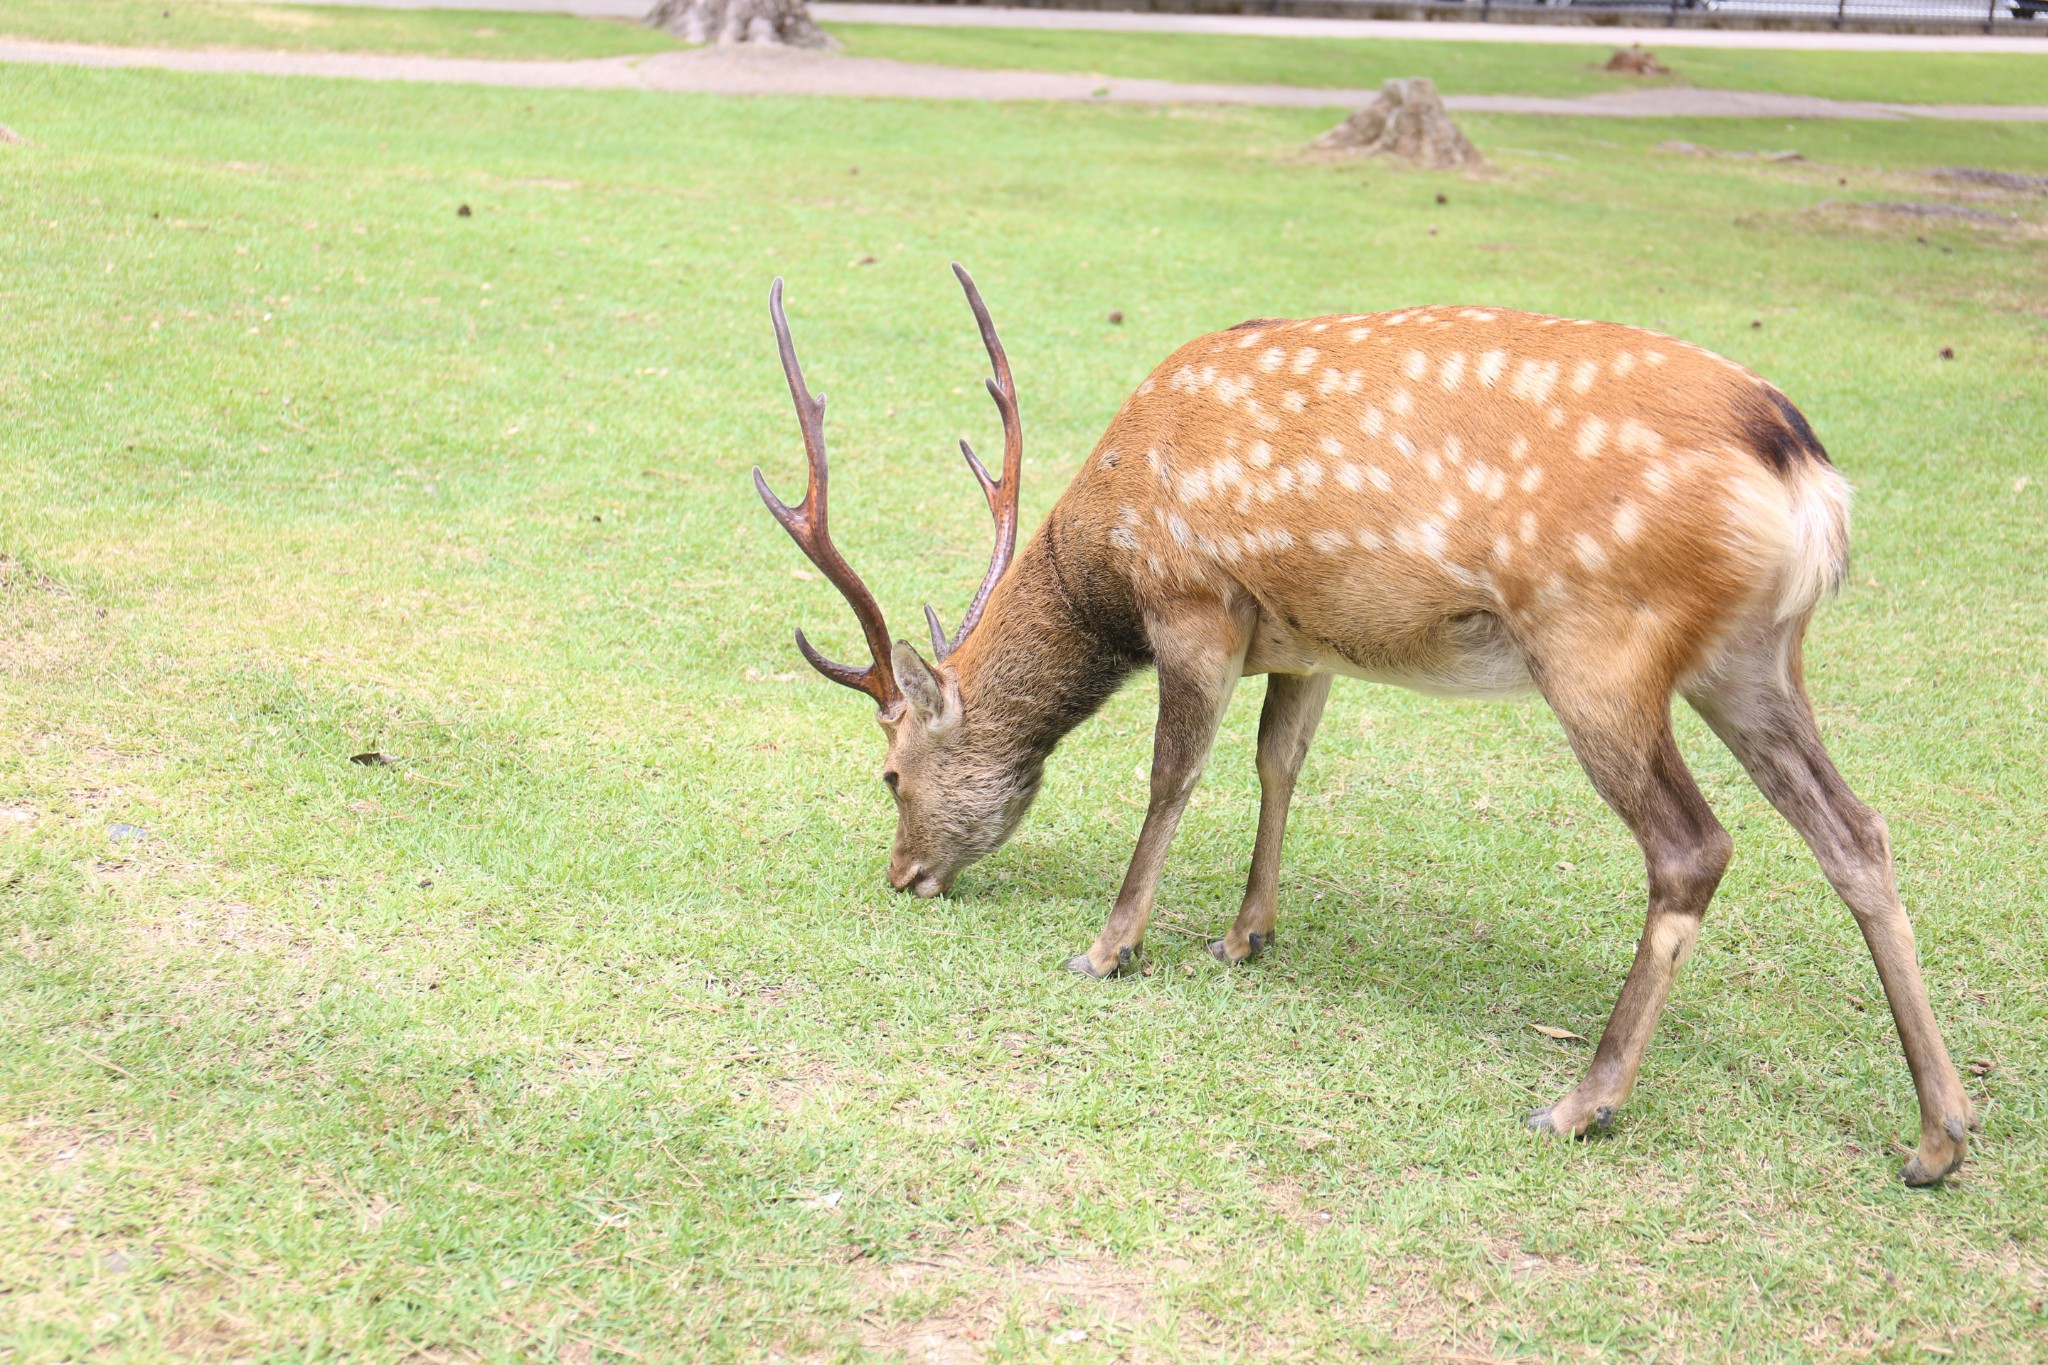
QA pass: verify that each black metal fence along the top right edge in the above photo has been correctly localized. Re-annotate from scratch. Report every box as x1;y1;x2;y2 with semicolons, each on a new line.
924;0;2048;35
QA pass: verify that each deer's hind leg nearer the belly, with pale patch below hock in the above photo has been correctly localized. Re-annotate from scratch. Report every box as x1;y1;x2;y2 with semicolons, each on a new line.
1530;665;1733;1136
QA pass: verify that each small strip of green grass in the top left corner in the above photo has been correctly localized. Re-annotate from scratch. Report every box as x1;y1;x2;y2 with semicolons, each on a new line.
0;0;678;57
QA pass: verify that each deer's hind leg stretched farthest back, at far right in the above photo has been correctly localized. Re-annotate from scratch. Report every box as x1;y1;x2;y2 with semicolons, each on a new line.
1686;622;1974;1185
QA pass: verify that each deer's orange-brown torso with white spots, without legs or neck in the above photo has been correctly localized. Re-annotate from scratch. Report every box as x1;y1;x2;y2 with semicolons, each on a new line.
1061;307;1833;692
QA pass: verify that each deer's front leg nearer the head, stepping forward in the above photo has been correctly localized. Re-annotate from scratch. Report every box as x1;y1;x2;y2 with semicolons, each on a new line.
1067;602;1251;976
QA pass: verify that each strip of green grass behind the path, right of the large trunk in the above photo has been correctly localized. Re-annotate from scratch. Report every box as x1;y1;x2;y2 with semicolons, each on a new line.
831;25;2048;104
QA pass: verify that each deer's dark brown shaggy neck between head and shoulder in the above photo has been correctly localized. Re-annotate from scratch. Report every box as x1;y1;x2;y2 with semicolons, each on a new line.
954;523;1147;763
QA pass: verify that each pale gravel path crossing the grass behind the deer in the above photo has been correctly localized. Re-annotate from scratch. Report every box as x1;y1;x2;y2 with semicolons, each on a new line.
0;39;2048;123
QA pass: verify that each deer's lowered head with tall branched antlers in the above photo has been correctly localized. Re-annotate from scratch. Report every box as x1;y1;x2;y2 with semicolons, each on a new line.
754;266;1040;896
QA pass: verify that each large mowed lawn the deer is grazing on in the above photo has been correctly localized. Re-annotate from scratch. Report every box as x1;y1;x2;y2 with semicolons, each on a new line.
0;58;2048;1363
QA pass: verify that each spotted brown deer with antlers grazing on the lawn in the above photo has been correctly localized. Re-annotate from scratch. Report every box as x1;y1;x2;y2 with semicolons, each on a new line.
754;266;1974;1185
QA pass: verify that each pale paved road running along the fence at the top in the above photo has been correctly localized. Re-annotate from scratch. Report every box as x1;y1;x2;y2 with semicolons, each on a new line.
268;0;2048;53
